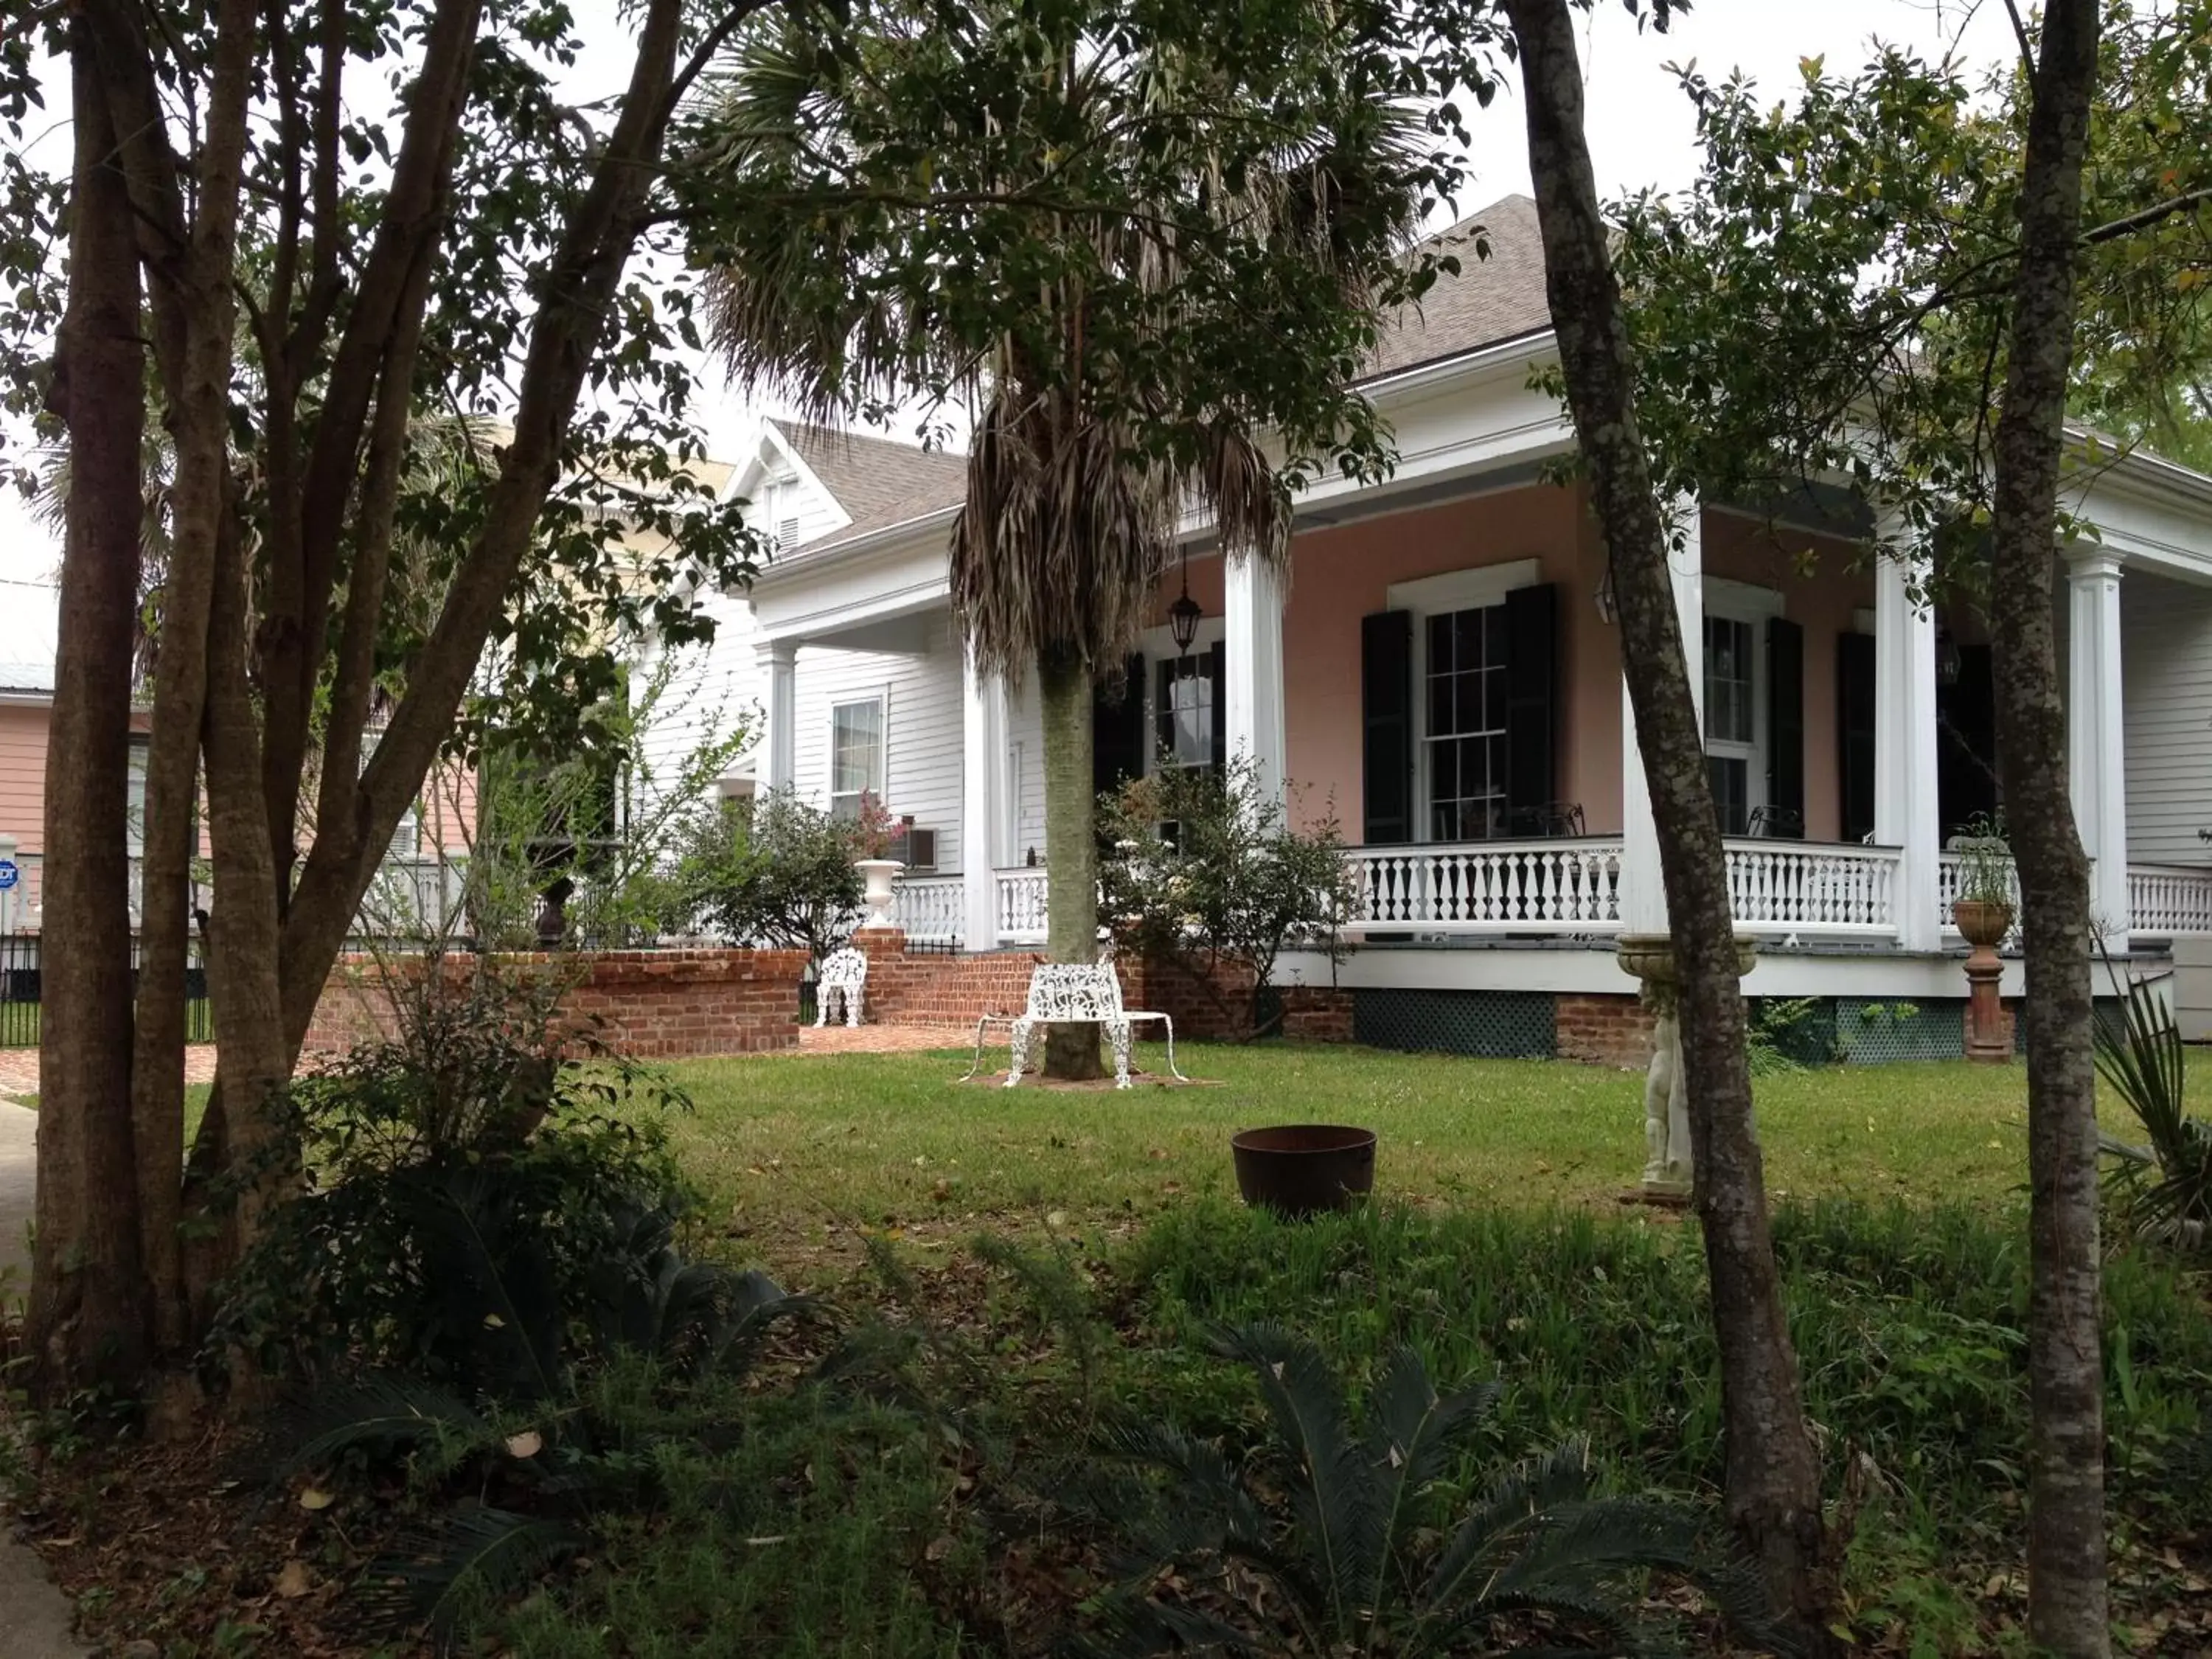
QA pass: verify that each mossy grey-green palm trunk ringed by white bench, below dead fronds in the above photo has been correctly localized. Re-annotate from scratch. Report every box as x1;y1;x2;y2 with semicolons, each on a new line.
1037;650;1106;1082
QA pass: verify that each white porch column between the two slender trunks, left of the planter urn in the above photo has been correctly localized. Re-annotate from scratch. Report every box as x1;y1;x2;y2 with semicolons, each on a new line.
1874;540;1942;951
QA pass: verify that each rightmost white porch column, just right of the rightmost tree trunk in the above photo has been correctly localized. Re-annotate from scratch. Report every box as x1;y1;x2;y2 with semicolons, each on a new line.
2066;546;2128;951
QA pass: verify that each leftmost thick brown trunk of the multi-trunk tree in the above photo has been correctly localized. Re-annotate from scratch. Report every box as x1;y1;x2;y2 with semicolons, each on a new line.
31;32;148;1394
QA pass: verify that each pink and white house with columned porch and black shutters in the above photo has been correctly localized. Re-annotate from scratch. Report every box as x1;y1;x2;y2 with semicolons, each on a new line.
646;199;2212;1055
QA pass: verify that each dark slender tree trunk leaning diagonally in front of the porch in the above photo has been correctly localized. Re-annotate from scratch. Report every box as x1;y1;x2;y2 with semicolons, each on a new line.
1506;0;1836;1650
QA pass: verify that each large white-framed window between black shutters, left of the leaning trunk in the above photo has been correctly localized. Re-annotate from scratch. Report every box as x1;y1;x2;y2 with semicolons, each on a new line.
1387;560;1544;841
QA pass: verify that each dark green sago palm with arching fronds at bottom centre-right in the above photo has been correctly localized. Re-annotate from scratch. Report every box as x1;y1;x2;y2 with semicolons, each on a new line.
1066;1325;1763;1659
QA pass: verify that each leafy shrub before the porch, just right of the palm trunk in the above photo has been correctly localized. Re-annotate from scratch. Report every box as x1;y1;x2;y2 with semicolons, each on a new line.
1099;759;1358;1037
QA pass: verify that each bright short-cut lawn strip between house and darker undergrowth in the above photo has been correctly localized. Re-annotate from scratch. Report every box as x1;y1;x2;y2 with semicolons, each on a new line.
650;1044;2053;1234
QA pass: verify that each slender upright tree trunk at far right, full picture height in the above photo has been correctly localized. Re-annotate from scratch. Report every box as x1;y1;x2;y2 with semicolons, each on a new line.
1989;0;2126;1659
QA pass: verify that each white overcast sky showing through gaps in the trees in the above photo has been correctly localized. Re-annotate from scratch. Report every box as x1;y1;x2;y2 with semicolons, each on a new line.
0;0;2013;584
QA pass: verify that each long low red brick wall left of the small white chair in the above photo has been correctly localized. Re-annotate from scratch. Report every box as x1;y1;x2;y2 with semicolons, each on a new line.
307;951;807;1060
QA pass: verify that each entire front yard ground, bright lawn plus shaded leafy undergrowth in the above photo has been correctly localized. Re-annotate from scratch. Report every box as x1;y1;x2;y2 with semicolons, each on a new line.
17;1044;2212;1659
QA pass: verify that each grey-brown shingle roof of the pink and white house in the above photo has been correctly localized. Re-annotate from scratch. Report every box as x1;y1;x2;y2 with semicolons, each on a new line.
774;195;1551;551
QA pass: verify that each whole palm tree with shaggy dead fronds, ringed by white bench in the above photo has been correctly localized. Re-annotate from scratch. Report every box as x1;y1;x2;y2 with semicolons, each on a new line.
690;0;1440;1077
